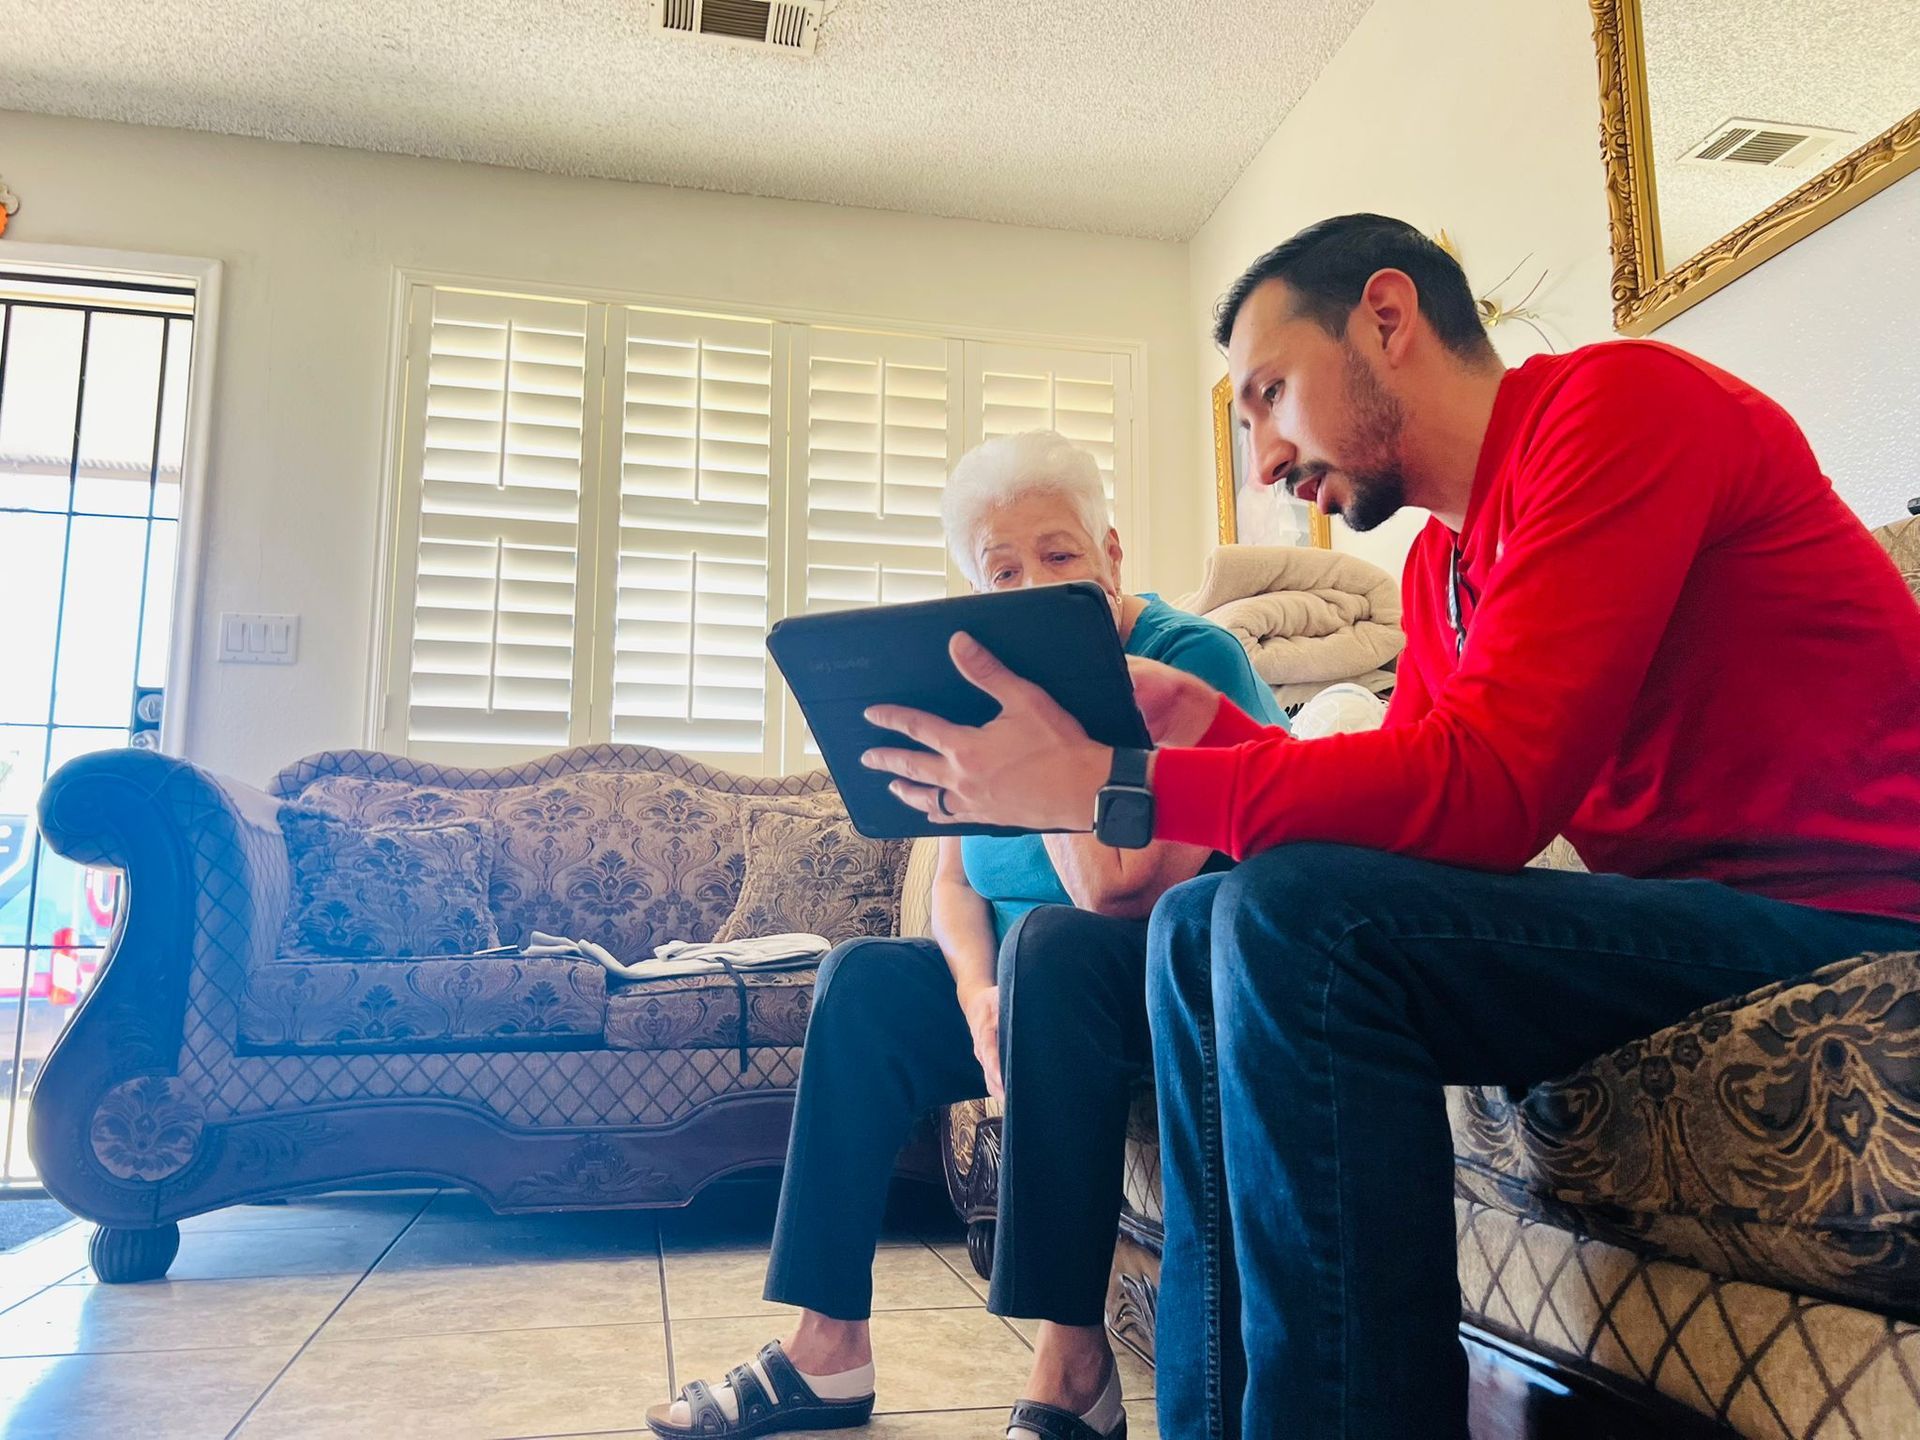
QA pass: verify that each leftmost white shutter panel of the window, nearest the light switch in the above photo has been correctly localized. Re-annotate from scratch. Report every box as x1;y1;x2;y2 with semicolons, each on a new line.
384;286;599;762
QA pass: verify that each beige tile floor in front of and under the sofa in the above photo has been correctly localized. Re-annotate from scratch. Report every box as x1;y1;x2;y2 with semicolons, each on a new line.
0;1185;1156;1440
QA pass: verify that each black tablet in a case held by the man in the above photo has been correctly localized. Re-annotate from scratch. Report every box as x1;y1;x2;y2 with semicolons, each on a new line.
766;580;1152;839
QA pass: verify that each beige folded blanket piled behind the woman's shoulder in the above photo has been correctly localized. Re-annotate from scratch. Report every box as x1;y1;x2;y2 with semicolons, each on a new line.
1179;545;1407;687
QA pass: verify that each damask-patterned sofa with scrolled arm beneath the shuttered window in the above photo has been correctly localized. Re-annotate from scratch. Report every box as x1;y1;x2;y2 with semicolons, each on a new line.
29;747;906;1279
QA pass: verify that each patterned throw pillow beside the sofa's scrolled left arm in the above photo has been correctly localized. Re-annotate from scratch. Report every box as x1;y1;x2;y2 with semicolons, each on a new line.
280;808;499;956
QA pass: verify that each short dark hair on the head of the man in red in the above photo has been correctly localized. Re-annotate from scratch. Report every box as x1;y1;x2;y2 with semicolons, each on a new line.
1213;215;1494;359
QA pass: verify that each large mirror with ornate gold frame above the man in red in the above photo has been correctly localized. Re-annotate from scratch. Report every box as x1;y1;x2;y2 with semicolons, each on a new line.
1592;0;1920;334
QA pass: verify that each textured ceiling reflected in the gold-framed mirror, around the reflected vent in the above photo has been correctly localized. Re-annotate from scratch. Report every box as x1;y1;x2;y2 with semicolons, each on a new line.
1642;0;1920;265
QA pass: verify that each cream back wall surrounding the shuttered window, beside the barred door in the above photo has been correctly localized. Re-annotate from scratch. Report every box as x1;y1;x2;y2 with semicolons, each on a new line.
0;113;1210;781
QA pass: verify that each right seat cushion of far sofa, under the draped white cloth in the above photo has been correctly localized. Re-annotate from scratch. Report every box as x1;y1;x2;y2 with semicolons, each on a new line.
607;966;816;1050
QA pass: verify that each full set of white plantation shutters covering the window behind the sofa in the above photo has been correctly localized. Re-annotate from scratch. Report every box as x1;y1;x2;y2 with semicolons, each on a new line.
380;282;1131;772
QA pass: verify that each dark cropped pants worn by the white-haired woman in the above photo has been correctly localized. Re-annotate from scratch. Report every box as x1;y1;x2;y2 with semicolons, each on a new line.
766;904;1152;1325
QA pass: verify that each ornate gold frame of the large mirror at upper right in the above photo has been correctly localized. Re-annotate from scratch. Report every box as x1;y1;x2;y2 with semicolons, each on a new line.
1592;0;1920;334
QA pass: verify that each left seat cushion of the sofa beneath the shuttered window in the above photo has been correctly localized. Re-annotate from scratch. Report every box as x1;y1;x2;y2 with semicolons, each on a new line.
240;958;607;1054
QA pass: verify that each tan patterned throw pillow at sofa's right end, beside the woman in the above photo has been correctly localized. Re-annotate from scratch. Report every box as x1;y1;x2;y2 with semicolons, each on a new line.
714;801;910;943
